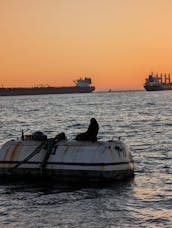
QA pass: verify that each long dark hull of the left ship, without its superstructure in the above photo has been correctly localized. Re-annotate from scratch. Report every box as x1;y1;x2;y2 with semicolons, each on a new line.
0;86;95;96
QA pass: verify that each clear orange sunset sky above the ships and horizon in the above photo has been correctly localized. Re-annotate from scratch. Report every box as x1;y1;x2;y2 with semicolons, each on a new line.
0;0;172;90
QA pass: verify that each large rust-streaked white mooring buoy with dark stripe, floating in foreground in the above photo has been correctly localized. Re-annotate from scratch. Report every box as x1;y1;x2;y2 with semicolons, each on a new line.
0;136;134;181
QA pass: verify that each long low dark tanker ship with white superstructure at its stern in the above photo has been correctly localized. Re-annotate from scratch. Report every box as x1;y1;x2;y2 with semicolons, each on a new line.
0;77;95;96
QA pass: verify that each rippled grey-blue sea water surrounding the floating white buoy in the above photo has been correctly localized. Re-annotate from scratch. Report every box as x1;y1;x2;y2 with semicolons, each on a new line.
0;91;172;228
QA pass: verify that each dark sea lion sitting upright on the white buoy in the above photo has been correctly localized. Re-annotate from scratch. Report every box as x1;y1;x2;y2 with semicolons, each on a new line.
76;118;99;142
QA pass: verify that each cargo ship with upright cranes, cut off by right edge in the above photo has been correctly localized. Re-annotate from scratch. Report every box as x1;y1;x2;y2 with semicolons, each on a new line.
144;73;172;91
